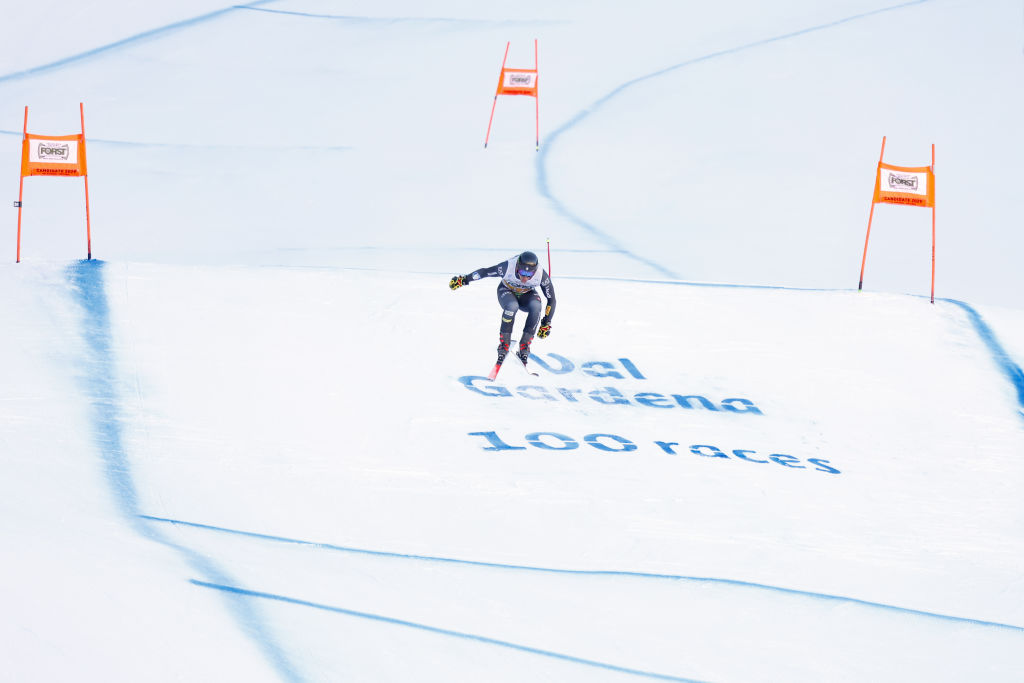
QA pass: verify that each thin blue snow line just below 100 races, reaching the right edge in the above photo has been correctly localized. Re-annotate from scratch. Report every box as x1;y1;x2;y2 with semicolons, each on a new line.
141;515;1024;632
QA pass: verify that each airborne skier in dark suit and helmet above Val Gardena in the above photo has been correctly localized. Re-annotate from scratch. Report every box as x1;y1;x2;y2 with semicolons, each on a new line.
449;251;555;370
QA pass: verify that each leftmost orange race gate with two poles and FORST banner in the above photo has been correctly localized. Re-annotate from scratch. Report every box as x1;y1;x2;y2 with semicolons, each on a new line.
14;102;92;263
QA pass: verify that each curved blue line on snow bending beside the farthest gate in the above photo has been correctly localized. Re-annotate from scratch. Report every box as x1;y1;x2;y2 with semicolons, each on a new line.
537;0;930;280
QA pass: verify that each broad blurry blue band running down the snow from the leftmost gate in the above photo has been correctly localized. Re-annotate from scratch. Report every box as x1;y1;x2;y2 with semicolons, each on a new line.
67;259;303;683
